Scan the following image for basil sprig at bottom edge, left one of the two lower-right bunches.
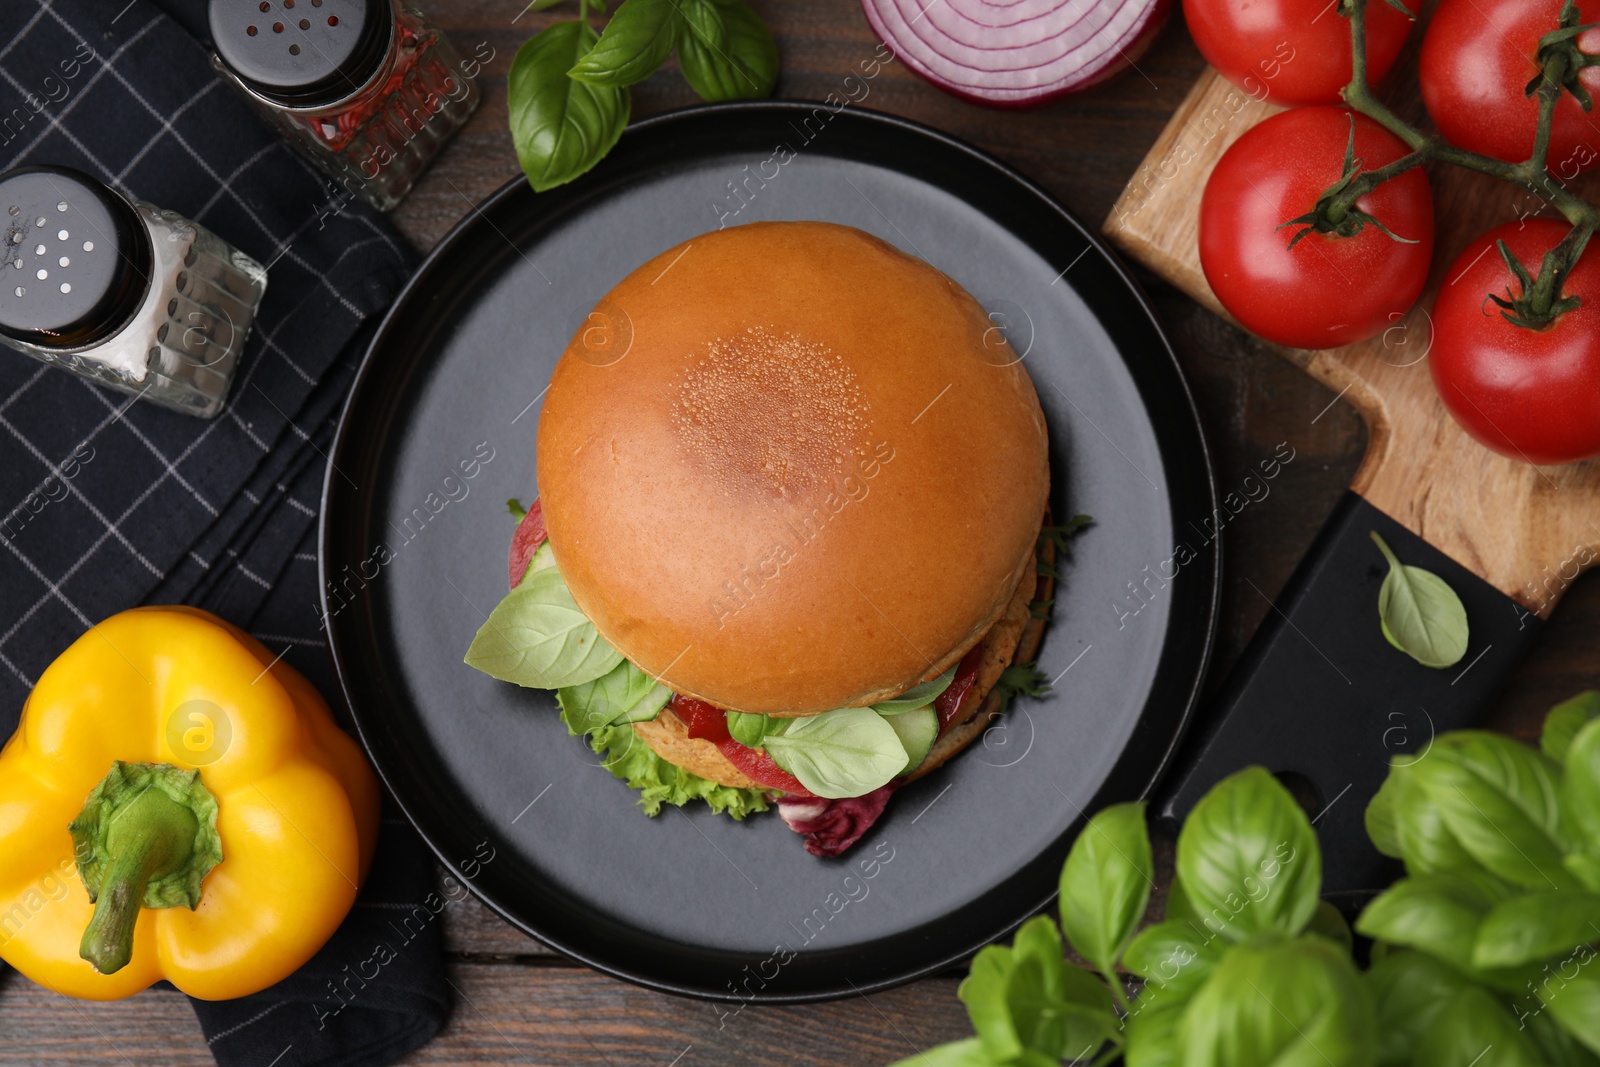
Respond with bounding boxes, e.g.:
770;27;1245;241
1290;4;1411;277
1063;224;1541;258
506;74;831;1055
896;768;1387;1067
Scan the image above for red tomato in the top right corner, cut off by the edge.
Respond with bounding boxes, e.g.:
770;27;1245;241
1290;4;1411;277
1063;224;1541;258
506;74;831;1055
1418;0;1600;178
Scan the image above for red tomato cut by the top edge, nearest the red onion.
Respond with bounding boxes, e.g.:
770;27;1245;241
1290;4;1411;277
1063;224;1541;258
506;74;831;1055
1184;0;1420;106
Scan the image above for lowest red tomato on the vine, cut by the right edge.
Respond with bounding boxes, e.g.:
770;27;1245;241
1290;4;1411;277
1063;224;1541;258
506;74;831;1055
1427;219;1600;464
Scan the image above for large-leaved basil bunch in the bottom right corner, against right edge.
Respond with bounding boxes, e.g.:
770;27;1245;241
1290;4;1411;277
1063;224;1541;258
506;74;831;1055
1355;693;1600;1064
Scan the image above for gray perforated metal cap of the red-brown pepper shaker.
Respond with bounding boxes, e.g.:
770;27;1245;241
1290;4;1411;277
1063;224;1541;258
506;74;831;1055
210;0;394;107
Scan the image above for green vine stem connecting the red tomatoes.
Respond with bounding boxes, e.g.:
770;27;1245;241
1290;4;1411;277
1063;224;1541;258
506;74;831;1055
1302;0;1600;330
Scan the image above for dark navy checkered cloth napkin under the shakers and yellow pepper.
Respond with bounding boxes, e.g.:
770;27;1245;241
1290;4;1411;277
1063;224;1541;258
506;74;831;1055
0;0;448;1067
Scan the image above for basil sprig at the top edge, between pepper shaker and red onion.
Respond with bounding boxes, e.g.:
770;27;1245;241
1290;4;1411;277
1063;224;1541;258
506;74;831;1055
507;0;778;192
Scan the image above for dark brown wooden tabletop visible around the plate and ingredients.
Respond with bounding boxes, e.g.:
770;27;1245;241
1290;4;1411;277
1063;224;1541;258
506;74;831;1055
0;0;1600;1067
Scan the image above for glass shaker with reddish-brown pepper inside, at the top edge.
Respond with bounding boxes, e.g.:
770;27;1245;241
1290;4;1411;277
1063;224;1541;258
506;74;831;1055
210;0;480;211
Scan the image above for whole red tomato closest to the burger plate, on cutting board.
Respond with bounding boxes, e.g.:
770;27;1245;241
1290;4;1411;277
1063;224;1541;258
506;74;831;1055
1200;107;1434;349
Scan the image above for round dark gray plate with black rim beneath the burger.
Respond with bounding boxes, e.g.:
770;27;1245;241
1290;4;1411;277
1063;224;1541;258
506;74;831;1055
322;102;1218;1001
